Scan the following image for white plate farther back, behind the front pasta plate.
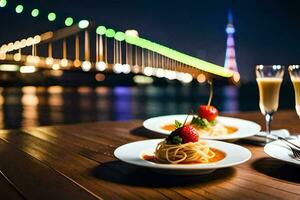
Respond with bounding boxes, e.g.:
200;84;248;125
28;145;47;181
143;115;261;140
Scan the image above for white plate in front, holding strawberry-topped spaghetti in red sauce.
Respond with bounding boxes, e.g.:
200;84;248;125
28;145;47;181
114;139;251;175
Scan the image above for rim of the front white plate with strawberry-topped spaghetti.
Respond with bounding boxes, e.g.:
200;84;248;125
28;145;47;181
114;139;252;171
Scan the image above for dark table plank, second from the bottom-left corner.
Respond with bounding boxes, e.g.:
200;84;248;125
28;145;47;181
0;140;96;199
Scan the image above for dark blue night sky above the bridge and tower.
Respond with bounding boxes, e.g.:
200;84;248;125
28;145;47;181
0;0;300;80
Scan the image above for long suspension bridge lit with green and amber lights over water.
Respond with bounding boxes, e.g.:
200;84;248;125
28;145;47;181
0;0;240;83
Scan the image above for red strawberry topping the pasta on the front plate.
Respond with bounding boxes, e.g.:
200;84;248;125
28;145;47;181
167;125;199;144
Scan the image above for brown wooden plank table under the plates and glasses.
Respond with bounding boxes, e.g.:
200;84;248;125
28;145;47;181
0;111;300;200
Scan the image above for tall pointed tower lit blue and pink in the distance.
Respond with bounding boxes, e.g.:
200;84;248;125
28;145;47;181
224;11;238;72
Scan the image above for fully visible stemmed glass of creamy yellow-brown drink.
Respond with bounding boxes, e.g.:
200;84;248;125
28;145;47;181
256;65;284;138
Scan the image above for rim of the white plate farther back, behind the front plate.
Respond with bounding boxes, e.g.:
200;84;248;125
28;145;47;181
143;114;261;140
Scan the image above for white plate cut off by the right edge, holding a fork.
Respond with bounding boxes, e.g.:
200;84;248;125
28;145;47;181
264;140;300;165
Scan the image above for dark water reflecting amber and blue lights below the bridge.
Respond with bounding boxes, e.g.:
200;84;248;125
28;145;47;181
0;84;294;129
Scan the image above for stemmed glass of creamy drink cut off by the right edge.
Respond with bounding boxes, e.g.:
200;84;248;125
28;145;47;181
289;65;300;117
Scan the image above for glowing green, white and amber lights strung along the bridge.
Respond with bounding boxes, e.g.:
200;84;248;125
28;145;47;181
0;0;233;82
